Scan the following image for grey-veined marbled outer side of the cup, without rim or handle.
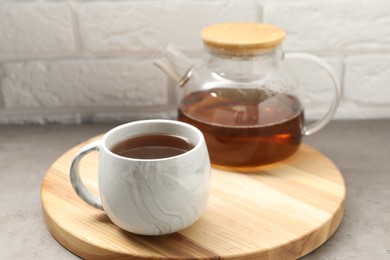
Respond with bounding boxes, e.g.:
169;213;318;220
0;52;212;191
99;144;211;235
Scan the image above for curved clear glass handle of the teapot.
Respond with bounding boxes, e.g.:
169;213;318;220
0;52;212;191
284;52;341;135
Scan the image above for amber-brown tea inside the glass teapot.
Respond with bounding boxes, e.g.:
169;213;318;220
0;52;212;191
178;88;303;167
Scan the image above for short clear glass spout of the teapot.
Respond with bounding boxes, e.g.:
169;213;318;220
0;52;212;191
153;44;193;86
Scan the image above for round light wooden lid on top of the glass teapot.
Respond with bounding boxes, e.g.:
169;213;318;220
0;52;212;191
201;22;285;54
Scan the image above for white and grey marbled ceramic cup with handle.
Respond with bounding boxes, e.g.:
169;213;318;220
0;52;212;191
70;120;211;235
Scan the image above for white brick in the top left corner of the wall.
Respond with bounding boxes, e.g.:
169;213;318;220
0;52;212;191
0;2;75;55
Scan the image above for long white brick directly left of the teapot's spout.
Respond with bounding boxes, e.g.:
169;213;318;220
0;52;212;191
0;59;168;109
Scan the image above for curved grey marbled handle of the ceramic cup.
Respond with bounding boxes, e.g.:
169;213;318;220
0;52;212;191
70;140;103;210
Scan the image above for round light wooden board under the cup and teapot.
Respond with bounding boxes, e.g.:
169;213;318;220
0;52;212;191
41;137;345;259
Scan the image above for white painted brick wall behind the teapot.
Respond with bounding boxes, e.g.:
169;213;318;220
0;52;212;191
0;0;390;124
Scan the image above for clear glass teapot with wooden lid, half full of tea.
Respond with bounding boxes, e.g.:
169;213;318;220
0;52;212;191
155;23;340;171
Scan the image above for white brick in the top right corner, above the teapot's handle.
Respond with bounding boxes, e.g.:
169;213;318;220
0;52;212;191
264;0;390;51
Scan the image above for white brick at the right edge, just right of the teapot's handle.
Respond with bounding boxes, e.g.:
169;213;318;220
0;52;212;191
345;55;390;106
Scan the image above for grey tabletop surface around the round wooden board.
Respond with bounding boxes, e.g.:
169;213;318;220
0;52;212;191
0;120;390;259
